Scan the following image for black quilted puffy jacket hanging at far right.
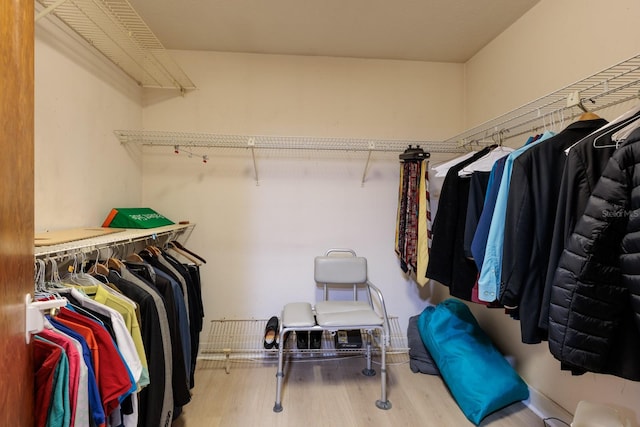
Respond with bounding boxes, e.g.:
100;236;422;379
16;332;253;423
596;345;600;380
549;131;640;381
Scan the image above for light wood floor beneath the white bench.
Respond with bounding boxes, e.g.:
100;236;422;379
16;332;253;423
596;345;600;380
172;355;544;427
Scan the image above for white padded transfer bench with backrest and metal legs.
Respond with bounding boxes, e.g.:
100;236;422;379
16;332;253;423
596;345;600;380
273;249;391;412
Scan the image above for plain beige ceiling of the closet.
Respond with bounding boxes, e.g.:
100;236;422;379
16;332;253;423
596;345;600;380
129;0;539;62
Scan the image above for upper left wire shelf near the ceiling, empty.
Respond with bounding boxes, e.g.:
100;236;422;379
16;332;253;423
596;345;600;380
35;0;195;94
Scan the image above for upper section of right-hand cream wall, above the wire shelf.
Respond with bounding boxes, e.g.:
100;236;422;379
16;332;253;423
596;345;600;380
465;0;640;127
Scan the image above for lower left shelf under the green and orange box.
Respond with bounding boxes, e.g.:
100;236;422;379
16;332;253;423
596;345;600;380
34;224;195;258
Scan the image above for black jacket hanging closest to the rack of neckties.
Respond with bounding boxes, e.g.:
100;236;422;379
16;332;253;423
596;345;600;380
426;147;495;301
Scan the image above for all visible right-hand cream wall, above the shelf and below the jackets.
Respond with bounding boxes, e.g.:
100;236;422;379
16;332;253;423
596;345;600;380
466;0;640;422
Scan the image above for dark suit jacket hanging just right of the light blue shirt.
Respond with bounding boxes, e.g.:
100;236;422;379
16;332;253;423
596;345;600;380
499;119;607;344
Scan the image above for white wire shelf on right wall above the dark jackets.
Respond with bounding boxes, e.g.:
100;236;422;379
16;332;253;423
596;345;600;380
444;55;640;147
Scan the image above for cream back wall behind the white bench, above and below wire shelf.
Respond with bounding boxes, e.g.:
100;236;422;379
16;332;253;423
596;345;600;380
143;52;463;340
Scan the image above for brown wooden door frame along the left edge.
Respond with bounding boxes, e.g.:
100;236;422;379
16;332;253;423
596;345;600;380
0;0;34;426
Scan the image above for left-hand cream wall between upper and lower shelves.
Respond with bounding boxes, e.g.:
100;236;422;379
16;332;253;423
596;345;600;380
35;19;142;232
